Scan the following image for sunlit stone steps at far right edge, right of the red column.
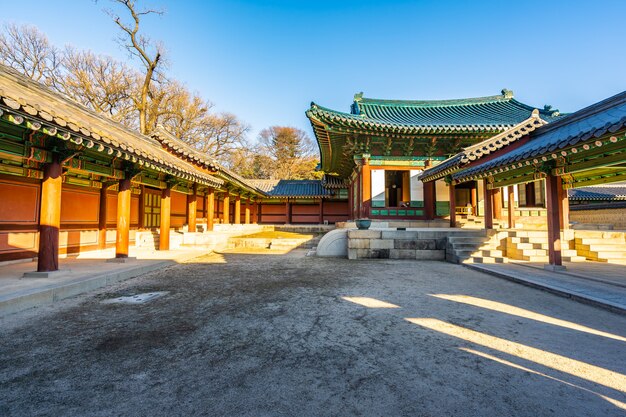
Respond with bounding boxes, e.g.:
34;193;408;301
574;231;626;265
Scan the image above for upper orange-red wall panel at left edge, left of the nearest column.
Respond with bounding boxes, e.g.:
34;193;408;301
0;179;40;226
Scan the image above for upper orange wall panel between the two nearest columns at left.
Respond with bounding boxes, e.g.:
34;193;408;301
61;187;100;224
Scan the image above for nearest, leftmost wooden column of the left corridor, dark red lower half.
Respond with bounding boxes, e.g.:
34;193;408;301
37;156;63;272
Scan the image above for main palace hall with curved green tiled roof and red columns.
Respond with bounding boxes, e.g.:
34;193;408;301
307;90;561;220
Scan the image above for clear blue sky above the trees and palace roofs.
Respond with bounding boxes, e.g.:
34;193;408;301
0;0;626;143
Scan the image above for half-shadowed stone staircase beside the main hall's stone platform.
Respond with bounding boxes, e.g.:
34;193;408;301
446;231;506;263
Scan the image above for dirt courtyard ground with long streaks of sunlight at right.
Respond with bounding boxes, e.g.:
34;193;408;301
0;251;626;417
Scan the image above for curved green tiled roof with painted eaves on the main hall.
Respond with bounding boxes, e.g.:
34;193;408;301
306;90;561;178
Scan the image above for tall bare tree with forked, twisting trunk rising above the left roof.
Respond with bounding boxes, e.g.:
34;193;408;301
108;0;163;134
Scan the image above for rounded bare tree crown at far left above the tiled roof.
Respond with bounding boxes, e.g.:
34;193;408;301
0;23;62;87
